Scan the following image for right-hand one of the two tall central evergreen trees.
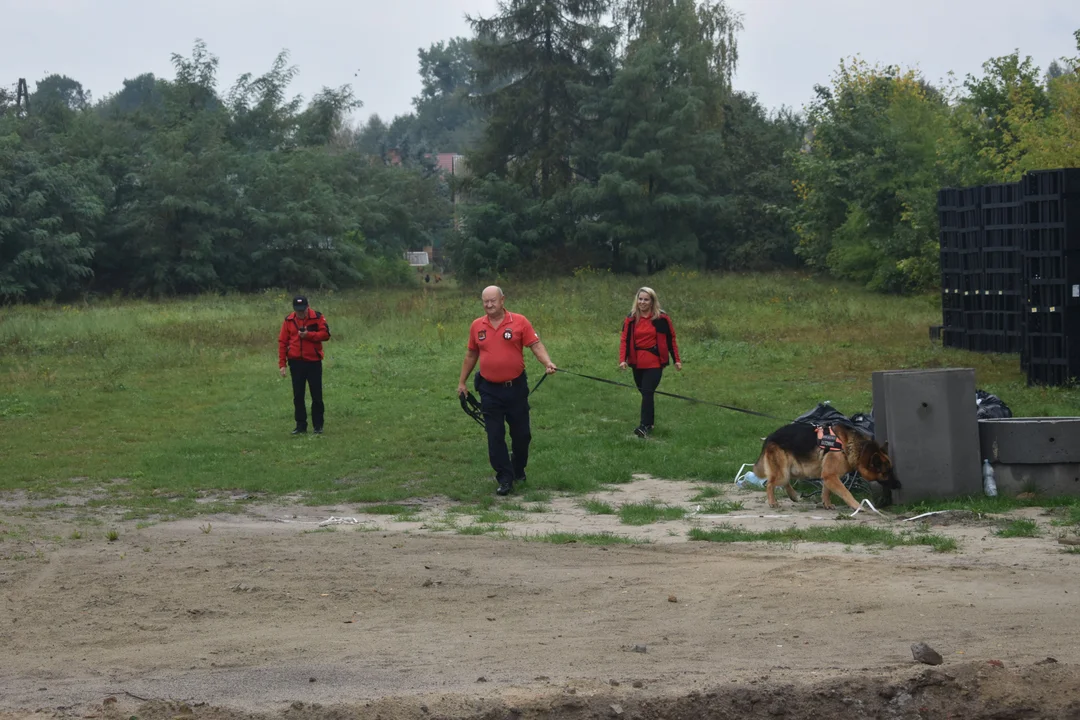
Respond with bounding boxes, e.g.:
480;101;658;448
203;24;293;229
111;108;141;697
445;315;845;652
573;0;734;272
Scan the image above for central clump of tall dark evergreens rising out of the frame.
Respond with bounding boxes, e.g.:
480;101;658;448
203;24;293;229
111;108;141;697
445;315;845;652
442;0;806;275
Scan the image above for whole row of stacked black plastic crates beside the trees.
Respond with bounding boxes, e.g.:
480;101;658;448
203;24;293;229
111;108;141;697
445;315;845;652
937;169;1080;385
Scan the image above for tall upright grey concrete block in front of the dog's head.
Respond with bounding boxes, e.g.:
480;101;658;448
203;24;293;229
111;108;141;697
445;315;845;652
873;368;983;503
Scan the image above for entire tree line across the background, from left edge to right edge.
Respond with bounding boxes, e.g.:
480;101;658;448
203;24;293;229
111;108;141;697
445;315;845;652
0;0;1080;301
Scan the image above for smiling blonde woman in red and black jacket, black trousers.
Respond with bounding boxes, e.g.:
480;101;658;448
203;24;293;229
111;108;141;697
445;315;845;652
619;287;683;437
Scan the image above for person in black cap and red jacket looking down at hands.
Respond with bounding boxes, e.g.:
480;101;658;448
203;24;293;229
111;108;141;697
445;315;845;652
278;295;330;435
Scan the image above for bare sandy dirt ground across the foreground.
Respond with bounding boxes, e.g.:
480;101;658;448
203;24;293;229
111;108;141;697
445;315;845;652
0;477;1080;720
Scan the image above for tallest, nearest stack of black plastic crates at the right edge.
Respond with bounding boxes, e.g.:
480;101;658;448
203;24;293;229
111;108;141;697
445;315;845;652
1021;168;1080;385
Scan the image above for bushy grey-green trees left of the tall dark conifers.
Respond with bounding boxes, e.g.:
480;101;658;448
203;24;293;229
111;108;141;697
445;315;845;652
0;43;450;301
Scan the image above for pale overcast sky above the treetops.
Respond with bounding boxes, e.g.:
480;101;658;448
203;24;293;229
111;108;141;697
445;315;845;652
0;0;1080;120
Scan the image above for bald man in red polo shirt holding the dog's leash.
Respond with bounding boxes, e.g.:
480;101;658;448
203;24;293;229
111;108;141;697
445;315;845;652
458;285;558;495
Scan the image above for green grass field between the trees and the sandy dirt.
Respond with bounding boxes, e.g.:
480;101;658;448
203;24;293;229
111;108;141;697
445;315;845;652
0;271;1080;517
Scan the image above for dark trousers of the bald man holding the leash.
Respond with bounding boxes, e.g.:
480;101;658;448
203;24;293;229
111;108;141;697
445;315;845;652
474;372;532;483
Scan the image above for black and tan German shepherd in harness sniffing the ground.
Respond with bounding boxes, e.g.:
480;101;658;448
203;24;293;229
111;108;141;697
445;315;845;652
754;422;900;510
